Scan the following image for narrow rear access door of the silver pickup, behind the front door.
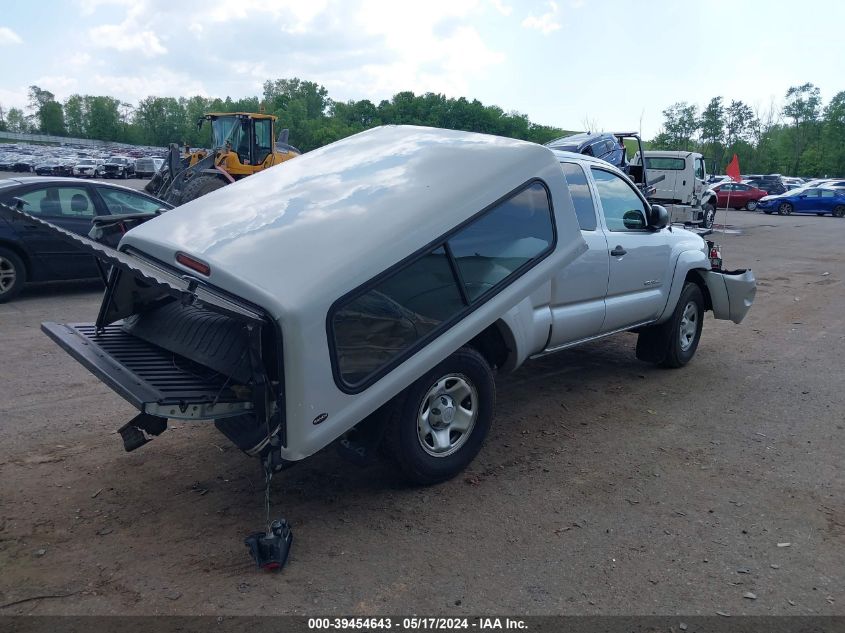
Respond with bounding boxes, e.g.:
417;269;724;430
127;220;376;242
549;158;610;348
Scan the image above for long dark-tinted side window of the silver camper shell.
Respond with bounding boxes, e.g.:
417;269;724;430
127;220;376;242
328;181;555;393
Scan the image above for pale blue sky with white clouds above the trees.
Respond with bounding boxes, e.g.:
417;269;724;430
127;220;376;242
0;0;845;138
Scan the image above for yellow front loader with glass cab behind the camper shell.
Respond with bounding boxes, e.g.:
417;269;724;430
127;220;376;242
145;112;300;205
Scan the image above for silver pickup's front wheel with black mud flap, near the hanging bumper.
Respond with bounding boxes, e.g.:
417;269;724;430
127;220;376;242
637;282;704;368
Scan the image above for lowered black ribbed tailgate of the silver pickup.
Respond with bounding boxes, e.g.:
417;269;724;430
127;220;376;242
41;323;252;419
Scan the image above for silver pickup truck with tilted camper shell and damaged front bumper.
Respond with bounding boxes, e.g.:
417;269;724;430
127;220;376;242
24;126;755;483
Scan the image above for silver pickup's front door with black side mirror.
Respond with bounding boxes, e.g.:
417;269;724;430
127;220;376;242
591;166;671;332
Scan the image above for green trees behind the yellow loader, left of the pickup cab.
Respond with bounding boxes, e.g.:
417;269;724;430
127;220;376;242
0;78;567;151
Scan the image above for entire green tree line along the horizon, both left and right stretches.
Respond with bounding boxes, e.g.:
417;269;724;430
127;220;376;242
0;78;845;176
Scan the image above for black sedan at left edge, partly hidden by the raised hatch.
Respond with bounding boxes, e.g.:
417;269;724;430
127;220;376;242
0;177;173;303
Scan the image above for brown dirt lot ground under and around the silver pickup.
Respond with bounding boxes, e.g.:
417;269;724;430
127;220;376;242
0;211;845;615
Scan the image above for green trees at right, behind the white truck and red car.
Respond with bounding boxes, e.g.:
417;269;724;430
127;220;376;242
649;83;845;176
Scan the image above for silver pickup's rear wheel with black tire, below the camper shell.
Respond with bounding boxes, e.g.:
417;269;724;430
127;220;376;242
385;347;496;486
